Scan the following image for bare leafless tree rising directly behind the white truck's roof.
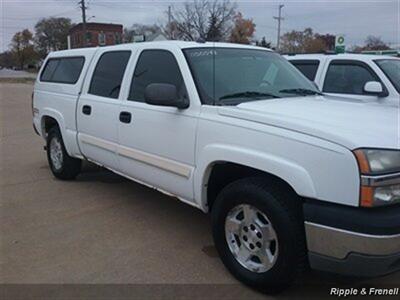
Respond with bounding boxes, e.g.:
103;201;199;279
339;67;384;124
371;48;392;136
166;0;236;41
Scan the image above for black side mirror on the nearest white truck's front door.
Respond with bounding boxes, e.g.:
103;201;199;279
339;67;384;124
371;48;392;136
144;83;189;109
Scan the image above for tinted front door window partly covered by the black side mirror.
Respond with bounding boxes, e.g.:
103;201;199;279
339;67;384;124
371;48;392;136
128;50;185;102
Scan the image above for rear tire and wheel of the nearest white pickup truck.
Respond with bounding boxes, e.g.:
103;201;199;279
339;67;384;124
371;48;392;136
47;126;82;180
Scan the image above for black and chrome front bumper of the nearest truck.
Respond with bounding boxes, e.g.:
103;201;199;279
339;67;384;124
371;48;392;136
304;202;400;276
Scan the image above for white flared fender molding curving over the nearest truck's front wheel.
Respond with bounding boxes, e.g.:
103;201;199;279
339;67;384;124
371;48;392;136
194;144;316;212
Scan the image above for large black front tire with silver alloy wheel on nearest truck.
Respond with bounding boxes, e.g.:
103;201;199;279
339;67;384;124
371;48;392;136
211;178;306;293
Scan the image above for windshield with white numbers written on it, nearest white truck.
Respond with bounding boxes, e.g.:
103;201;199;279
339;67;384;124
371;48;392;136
184;47;321;105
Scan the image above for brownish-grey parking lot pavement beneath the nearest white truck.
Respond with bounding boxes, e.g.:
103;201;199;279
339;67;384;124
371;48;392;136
0;83;400;299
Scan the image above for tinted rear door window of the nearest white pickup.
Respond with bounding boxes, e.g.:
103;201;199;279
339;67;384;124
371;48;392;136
89;51;131;99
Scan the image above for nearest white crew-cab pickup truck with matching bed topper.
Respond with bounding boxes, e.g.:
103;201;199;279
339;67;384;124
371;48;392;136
32;41;400;292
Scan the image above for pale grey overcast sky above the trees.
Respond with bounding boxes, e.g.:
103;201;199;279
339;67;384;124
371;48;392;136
0;0;400;51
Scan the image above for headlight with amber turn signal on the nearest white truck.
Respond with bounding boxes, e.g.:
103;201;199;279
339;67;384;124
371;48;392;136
354;149;400;207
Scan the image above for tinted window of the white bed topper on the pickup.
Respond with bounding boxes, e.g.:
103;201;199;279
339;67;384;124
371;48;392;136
40;57;85;84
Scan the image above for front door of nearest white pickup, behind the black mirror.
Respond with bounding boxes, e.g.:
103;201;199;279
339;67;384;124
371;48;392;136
118;49;200;202
